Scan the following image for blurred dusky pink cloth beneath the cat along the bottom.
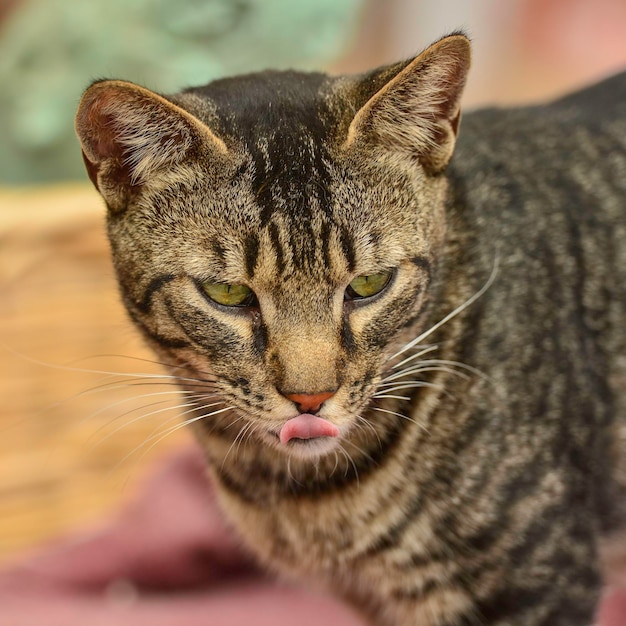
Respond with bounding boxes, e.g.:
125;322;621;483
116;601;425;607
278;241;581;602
0;449;626;626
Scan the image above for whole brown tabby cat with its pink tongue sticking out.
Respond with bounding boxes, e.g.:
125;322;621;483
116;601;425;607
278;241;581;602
76;33;626;626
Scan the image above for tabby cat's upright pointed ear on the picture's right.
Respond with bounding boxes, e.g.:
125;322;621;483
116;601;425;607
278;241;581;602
344;34;471;173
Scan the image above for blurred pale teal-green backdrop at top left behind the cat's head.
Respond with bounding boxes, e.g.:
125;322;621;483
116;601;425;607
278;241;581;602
0;0;362;184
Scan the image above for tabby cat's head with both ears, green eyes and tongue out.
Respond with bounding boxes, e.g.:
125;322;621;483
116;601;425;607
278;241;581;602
76;35;469;458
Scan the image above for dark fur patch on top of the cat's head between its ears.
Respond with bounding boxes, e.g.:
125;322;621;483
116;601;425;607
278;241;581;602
189;72;338;226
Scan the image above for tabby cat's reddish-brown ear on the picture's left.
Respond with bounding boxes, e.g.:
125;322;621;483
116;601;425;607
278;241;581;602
75;80;227;210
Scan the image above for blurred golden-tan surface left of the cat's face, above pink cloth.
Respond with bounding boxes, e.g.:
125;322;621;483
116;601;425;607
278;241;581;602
0;186;187;561
